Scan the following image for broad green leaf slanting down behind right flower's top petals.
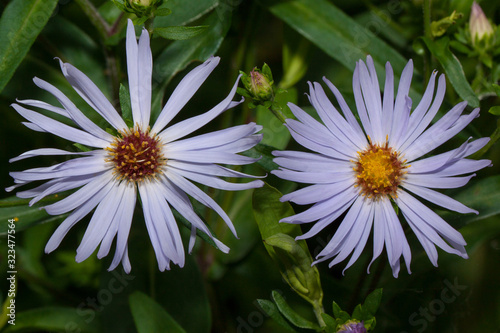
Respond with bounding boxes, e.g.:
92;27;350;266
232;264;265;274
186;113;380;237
258;0;407;87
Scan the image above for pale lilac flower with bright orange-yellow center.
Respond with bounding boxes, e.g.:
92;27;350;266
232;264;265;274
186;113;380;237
273;56;491;277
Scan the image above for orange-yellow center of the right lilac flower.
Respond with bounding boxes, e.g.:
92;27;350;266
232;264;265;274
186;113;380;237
353;143;409;199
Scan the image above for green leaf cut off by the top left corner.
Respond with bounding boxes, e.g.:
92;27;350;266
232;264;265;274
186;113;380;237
0;0;58;92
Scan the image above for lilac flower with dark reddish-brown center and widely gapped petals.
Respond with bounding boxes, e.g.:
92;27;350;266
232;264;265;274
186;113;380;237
7;20;263;272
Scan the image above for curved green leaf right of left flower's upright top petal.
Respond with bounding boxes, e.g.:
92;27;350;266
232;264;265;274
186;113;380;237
151;7;231;119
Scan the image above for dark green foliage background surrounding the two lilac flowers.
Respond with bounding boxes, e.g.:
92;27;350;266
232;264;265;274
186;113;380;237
0;0;500;333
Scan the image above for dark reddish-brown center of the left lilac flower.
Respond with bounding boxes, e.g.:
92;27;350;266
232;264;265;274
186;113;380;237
106;127;166;182
